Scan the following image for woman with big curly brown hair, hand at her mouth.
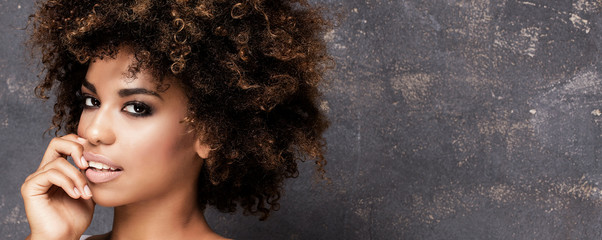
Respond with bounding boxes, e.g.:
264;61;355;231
21;0;329;239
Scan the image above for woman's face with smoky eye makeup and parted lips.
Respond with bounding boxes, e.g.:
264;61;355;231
77;51;204;206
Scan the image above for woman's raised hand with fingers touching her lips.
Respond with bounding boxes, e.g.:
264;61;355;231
21;134;95;240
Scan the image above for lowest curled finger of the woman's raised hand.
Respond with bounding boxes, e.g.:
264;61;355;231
21;169;82;199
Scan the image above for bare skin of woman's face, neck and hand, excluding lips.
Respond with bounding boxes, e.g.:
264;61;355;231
21;48;224;240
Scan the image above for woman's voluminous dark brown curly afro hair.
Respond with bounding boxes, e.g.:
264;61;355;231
30;0;331;220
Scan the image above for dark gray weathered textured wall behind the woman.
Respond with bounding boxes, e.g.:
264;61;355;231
0;0;602;239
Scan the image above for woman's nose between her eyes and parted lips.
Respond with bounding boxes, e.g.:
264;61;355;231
79;107;115;145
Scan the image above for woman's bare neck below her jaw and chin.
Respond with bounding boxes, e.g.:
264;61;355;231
111;182;214;240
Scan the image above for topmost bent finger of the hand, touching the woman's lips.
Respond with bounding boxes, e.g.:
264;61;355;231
38;134;88;169
